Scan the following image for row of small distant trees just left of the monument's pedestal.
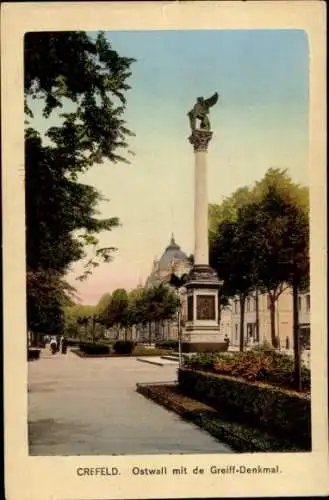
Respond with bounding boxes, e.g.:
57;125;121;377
65;283;179;341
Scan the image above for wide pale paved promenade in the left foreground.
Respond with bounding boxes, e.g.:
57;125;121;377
28;351;231;455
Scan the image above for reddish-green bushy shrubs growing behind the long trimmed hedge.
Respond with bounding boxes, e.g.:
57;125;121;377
185;349;311;391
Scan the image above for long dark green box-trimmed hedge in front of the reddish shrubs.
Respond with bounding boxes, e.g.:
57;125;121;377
178;368;311;450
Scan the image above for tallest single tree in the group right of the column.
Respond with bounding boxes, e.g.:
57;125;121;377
243;169;308;346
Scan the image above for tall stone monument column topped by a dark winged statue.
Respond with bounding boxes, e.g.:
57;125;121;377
182;94;224;352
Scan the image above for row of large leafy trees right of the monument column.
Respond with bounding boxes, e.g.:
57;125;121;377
209;169;309;386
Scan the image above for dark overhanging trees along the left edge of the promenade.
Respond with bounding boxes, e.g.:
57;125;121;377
24;32;133;344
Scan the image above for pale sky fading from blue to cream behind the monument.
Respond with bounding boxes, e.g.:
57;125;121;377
30;30;309;303
